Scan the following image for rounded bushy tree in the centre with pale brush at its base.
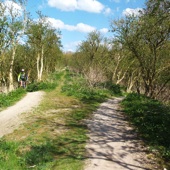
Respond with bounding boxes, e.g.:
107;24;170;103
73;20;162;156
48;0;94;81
74;31;108;86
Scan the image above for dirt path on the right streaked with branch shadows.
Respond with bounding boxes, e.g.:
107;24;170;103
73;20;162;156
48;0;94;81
85;98;156;170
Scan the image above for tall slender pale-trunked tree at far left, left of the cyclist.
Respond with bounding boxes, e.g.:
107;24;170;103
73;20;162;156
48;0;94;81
0;0;27;91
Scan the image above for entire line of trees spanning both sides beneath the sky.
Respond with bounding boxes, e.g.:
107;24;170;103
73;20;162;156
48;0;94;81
0;0;170;101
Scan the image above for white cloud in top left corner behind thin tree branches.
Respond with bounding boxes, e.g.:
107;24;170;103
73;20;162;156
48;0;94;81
2;0;23;17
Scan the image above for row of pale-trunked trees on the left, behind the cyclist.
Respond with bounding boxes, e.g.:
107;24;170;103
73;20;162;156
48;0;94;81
0;0;62;92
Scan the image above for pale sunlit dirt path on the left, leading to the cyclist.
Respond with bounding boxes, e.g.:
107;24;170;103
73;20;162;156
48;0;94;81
0;91;44;137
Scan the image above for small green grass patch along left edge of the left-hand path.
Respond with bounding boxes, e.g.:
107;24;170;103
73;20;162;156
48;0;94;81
0;88;26;108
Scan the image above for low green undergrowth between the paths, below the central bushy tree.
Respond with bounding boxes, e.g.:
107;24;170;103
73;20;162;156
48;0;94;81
62;72;121;103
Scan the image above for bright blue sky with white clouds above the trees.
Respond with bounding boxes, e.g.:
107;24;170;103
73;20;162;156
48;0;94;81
5;0;145;52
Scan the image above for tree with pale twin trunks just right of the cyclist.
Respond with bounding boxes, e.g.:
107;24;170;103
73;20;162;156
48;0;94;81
27;12;61;81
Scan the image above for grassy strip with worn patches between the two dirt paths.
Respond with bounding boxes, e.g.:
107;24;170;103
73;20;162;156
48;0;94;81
0;69;120;170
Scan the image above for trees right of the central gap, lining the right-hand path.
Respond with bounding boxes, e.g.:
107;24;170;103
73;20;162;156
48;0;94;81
64;0;170;101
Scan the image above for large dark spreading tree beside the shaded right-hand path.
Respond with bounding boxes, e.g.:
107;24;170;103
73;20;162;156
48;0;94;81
111;1;170;97
